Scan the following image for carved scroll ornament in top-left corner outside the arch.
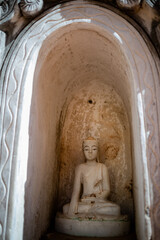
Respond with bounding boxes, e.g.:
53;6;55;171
0;0;44;35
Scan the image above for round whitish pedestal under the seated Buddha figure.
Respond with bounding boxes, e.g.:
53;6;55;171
55;214;130;237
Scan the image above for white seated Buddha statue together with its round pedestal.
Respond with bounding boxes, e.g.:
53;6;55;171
55;137;130;237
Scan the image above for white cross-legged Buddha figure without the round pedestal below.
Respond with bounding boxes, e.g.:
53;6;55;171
63;137;120;219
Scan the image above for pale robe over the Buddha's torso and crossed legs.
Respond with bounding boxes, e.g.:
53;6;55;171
63;163;120;219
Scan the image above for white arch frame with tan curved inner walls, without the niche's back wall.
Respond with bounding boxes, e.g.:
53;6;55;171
0;1;160;240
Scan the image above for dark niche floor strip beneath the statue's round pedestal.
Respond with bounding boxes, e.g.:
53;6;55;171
42;232;137;240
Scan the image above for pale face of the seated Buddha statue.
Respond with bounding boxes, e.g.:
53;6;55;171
83;140;98;161
